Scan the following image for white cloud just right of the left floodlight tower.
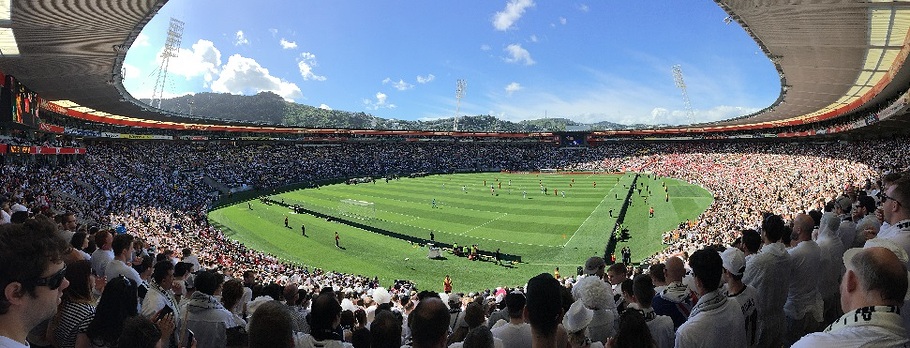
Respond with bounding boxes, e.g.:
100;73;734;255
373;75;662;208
164;39;221;87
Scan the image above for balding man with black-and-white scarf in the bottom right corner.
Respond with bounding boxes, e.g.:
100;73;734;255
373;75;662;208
793;239;910;348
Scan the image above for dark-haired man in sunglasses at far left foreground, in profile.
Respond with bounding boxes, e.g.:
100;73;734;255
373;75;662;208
0;220;70;347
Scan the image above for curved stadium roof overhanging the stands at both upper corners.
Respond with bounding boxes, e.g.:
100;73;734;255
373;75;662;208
0;0;910;133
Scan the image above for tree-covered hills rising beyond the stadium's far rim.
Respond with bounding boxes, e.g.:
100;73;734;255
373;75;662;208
141;92;651;132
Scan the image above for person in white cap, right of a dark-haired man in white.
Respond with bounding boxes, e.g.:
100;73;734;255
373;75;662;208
720;248;758;347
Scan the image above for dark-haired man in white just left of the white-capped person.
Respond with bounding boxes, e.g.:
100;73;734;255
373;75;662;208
675;248;748;348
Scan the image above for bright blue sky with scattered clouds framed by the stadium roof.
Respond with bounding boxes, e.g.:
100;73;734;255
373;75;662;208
124;0;780;124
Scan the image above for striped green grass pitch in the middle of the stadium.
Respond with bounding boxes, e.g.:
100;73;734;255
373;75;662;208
209;173;713;292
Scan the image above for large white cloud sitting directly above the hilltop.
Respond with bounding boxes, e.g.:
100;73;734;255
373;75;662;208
212;54;303;101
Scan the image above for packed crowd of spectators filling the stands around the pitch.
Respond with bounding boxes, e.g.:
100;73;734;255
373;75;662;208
0;139;910;347
